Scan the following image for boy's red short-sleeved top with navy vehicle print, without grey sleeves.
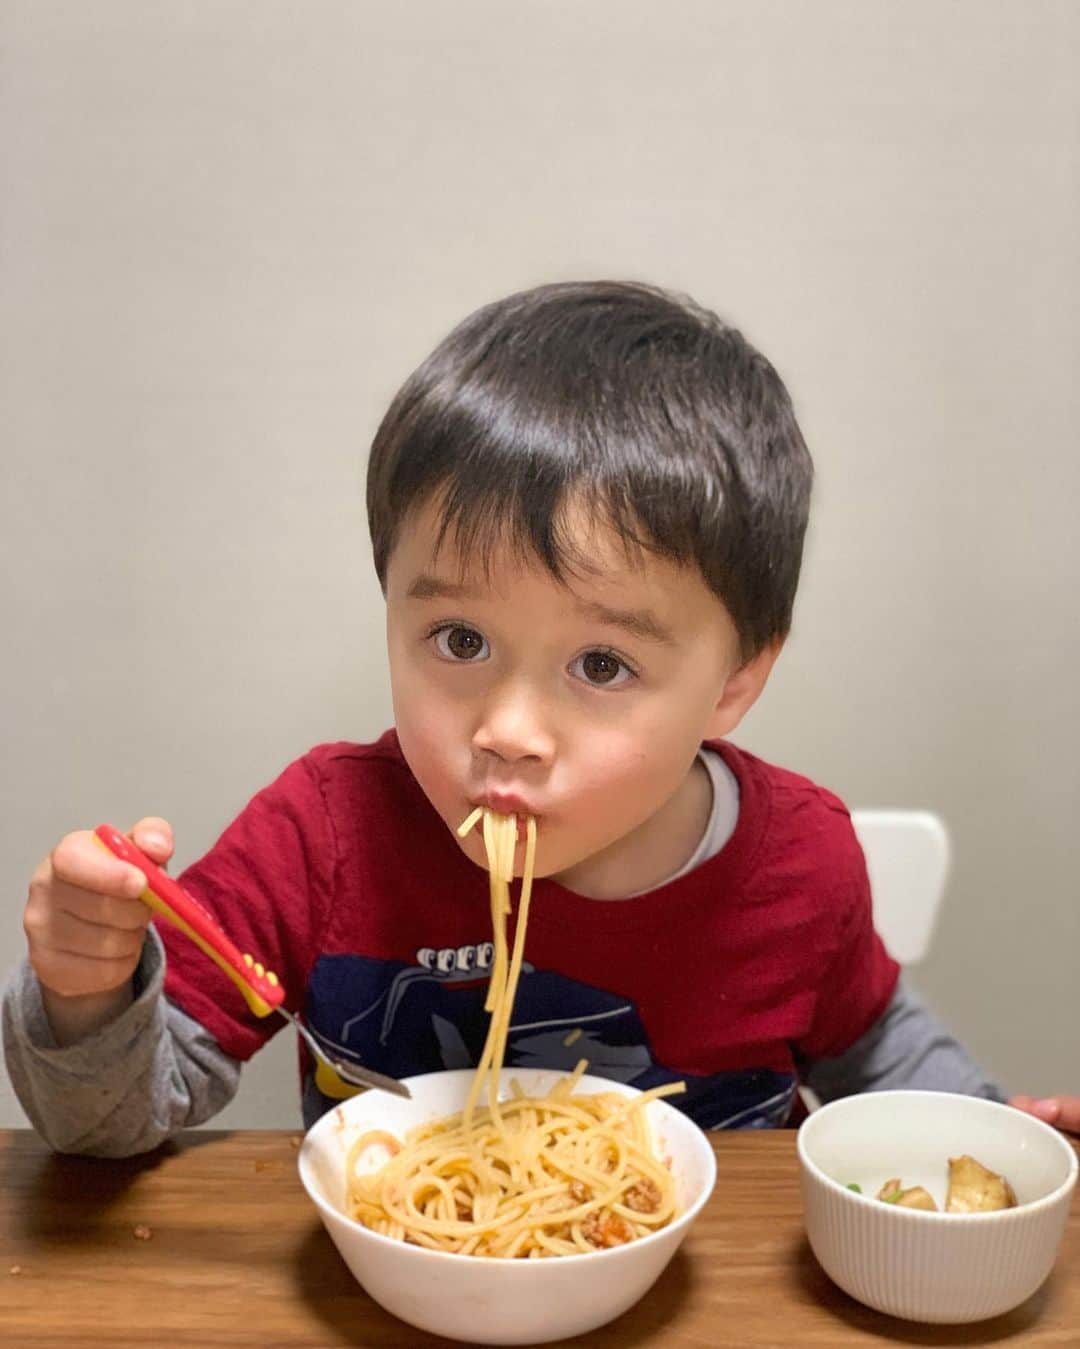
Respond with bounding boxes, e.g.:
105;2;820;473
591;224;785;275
159;731;898;1128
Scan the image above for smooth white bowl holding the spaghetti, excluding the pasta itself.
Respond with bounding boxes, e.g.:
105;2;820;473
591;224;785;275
299;1068;716;1345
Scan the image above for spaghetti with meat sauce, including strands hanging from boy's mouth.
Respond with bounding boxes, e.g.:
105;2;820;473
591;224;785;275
347;809;684;1259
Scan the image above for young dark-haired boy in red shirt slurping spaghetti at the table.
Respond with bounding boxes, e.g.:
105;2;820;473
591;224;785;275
4;283;1071;1155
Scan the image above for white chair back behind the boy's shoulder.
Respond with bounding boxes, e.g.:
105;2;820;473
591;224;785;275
851;811;949;965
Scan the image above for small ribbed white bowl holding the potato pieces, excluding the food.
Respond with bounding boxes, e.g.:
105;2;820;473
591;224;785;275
798;1091;1077;1323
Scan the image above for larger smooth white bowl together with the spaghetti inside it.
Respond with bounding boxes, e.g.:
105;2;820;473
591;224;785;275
299;1068;716;1345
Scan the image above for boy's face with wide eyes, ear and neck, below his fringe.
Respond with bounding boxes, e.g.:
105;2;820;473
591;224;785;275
387;505;774;898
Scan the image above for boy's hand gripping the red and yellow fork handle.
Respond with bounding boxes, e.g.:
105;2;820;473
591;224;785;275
23;816;173;1044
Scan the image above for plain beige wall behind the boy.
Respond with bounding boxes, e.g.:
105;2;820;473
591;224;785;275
0;0;1080;1125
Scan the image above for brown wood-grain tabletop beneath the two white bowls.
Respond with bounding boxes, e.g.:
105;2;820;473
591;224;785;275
0;1130;1080;1349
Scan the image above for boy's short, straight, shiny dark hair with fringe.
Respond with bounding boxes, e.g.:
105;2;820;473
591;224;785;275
368;282;812;658
